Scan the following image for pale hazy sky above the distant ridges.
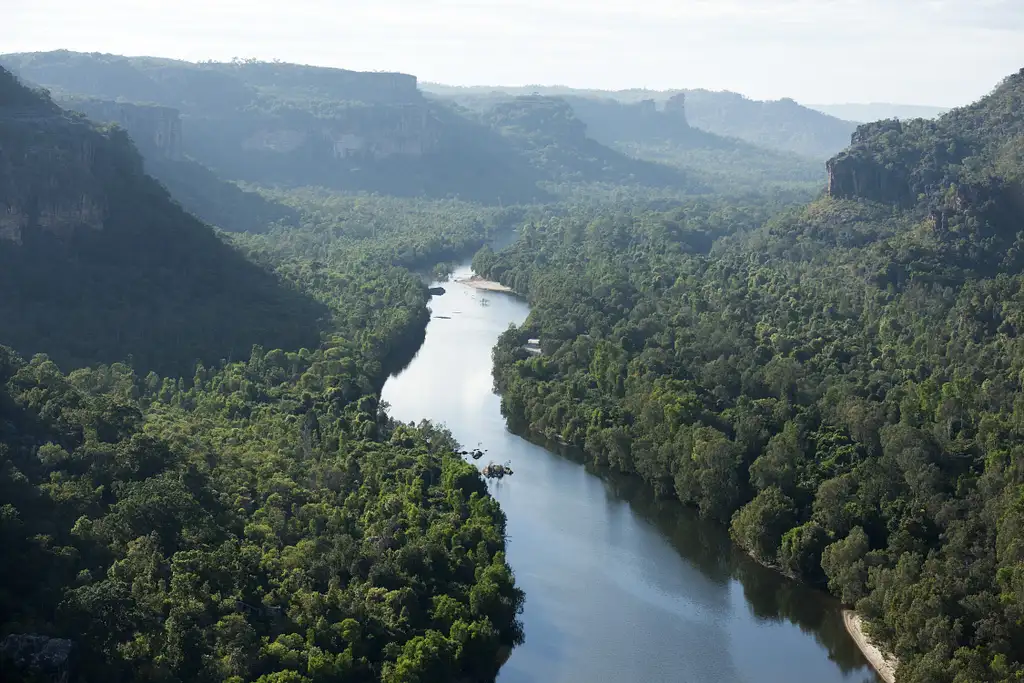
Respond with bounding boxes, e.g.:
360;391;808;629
8;0;1024;105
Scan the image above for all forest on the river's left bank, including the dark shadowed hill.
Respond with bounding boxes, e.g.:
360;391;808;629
0;65;523;683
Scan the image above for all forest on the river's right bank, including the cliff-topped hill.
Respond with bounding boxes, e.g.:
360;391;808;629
474;69;1024;683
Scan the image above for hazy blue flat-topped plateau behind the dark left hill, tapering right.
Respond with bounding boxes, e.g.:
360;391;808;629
0;51;708;201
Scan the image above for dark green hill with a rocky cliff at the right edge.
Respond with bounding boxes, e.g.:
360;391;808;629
827;70;1024;274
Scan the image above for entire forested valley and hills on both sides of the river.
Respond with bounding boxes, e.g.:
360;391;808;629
0;41;1024;683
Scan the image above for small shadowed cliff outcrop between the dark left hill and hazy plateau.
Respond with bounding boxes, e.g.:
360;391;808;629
59;98;182;161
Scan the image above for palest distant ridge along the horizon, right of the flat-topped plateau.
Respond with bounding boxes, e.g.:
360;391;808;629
422;83;855;160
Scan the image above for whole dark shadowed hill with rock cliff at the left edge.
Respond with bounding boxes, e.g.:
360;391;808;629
0;70;324;371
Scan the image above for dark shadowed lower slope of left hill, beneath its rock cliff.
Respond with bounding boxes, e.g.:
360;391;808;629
0;171;328;375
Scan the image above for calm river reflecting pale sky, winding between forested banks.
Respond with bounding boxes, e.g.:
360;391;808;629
383;267;879;683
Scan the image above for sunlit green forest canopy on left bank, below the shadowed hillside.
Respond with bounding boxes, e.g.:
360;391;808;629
0;347;522;681
